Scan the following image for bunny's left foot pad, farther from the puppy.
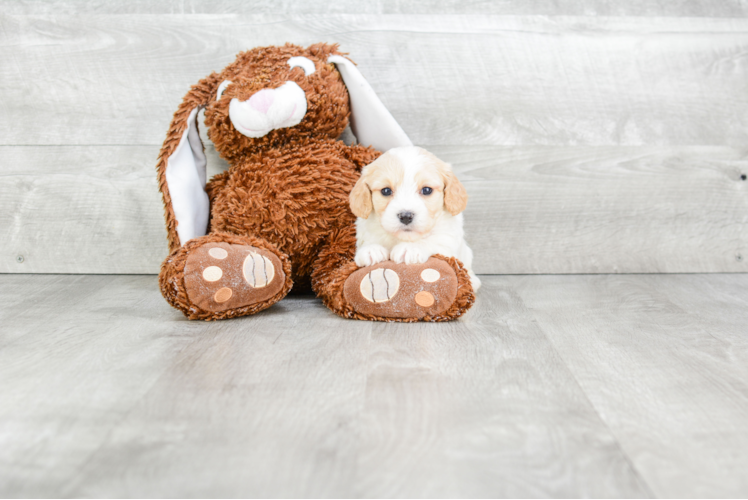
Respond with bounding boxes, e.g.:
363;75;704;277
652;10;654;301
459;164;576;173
184;242;286;312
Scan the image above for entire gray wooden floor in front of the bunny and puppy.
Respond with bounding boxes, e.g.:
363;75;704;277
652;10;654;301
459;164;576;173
0;274;748;498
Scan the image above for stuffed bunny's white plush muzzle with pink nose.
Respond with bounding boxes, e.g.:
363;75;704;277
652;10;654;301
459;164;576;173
229;82;307;138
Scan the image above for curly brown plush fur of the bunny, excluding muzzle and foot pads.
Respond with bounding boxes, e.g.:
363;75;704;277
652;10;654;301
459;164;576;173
157;44;474;321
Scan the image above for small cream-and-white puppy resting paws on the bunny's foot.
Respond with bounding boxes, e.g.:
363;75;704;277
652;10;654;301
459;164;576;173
350;146;480;290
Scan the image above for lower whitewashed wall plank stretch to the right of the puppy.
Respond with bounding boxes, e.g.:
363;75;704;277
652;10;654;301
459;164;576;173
444;147;748;274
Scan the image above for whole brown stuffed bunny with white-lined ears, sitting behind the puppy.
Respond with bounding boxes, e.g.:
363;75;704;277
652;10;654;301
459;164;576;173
157;44;474;321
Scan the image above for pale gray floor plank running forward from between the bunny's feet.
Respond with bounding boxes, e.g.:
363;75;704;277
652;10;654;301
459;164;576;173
63;292;372;498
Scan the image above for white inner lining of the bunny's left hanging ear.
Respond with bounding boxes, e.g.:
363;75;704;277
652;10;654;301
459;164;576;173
166;108;210;245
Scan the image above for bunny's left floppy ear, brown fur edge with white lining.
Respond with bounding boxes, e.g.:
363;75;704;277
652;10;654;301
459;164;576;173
156;73;218;252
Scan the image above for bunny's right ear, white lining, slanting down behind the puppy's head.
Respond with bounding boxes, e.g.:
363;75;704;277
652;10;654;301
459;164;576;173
327;55;413;151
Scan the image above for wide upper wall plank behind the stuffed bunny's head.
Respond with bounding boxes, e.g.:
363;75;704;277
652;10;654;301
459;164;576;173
0;13;748;146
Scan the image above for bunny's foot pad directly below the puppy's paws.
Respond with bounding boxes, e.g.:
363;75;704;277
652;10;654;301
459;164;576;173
343;257;458;320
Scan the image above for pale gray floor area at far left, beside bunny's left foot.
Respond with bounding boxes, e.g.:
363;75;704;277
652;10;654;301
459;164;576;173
0;275;199;498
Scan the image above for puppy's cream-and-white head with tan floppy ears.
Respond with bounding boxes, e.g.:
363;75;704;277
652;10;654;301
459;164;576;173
350;146;467;241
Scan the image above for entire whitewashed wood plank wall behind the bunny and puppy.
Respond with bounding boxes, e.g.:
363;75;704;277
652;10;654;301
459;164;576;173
0;0;748;274
